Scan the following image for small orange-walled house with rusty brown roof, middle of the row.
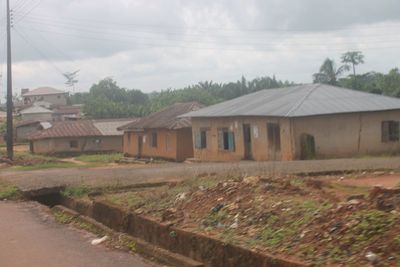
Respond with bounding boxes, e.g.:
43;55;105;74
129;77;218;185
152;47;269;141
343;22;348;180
121;102;202;161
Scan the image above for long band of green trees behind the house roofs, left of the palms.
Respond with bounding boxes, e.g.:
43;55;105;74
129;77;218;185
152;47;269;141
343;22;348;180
69;77;292;119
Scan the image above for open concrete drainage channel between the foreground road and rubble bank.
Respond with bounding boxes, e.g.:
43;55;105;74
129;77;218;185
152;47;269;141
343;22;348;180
24;187;307;267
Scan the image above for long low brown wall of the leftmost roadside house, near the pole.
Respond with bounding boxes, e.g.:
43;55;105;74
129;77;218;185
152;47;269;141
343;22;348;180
31;136;122;154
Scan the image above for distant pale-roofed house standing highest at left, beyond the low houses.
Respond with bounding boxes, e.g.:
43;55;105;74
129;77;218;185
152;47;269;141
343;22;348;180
21;87;68;106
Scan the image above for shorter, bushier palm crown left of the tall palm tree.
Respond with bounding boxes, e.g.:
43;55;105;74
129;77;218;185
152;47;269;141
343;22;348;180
313;58;349;85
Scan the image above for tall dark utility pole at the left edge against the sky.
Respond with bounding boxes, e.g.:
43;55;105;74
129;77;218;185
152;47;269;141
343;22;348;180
7;0;14;160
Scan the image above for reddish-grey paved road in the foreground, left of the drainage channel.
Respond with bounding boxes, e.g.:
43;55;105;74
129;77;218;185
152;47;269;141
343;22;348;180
0;201;159;267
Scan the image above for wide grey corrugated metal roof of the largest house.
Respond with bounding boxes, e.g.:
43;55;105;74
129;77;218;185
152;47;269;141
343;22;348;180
181;84;400;117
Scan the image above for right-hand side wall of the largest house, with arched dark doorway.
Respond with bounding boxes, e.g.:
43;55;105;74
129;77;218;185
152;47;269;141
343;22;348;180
293;111;400;158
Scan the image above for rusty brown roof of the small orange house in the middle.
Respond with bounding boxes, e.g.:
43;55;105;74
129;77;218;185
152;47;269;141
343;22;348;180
120;102;203;130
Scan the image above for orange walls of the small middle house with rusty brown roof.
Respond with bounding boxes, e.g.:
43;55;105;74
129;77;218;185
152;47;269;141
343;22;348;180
124;129;193;161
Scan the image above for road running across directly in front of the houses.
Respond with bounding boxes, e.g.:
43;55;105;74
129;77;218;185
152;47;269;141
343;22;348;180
0;157;400;193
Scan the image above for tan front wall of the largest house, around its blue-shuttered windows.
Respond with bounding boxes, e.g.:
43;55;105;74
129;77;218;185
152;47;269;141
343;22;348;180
192;117;293;161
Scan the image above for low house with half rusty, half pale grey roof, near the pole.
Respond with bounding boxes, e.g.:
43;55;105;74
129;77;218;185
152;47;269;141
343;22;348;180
29;119;136;154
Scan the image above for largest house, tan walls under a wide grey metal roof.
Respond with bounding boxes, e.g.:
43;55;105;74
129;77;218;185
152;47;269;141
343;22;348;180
183;84;400;161
